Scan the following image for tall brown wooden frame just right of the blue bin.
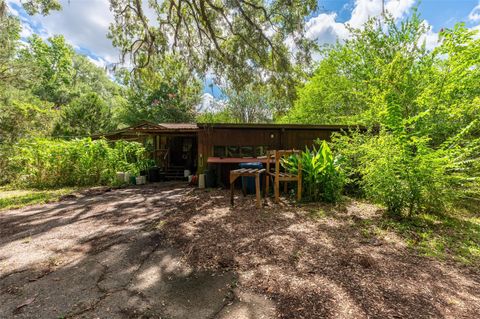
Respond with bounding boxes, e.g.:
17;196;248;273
265;150;302;203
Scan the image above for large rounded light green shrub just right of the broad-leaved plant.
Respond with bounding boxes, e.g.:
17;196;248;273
335;131;456;215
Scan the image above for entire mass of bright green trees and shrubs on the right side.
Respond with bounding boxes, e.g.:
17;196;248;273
283;11;480;216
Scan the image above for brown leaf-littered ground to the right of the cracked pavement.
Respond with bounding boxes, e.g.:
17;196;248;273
158;191;480;318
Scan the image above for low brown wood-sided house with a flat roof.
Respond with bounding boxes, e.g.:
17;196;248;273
97;122;352;177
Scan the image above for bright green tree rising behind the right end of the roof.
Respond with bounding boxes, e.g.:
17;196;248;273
283;12;435;125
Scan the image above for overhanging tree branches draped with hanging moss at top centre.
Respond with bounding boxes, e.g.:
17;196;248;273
15;0;318;107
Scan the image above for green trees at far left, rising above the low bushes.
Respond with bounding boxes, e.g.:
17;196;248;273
0;12;124;139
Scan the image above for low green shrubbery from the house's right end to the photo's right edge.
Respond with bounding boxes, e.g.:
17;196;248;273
333;127;480;217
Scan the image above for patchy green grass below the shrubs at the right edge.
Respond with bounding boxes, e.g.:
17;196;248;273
362;211;480;265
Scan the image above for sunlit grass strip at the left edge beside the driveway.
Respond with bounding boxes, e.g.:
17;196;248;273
0;187;79;210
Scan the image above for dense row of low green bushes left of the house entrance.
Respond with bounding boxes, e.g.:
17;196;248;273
7;138;147;188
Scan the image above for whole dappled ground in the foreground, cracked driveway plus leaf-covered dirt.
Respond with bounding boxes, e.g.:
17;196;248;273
0;184;480;319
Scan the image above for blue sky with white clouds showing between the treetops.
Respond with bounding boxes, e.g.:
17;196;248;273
7;0;480;105
